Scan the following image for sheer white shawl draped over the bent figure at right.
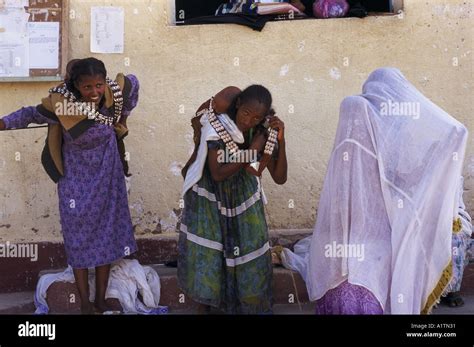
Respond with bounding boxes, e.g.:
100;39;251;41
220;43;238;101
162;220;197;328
306;68;468;314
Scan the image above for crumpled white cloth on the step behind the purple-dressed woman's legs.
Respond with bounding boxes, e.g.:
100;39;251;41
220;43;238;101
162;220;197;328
35;259;168;314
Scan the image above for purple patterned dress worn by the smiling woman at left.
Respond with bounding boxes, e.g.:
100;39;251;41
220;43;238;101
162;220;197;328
3;75;139;269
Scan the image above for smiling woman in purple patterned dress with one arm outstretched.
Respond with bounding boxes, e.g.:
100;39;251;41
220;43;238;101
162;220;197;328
0;58;139;313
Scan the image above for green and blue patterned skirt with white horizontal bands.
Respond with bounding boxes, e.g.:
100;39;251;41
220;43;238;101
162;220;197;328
178;165;272;314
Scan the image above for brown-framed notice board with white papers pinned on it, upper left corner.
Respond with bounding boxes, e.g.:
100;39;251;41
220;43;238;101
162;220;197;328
0;0;68;82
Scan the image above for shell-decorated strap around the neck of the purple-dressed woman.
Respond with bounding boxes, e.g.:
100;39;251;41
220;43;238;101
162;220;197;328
49;78;123;126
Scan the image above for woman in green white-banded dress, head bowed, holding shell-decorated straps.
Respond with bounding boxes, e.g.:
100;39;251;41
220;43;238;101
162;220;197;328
178;85;287;314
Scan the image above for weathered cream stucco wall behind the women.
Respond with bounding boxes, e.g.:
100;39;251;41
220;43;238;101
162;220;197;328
0;0;474;241
